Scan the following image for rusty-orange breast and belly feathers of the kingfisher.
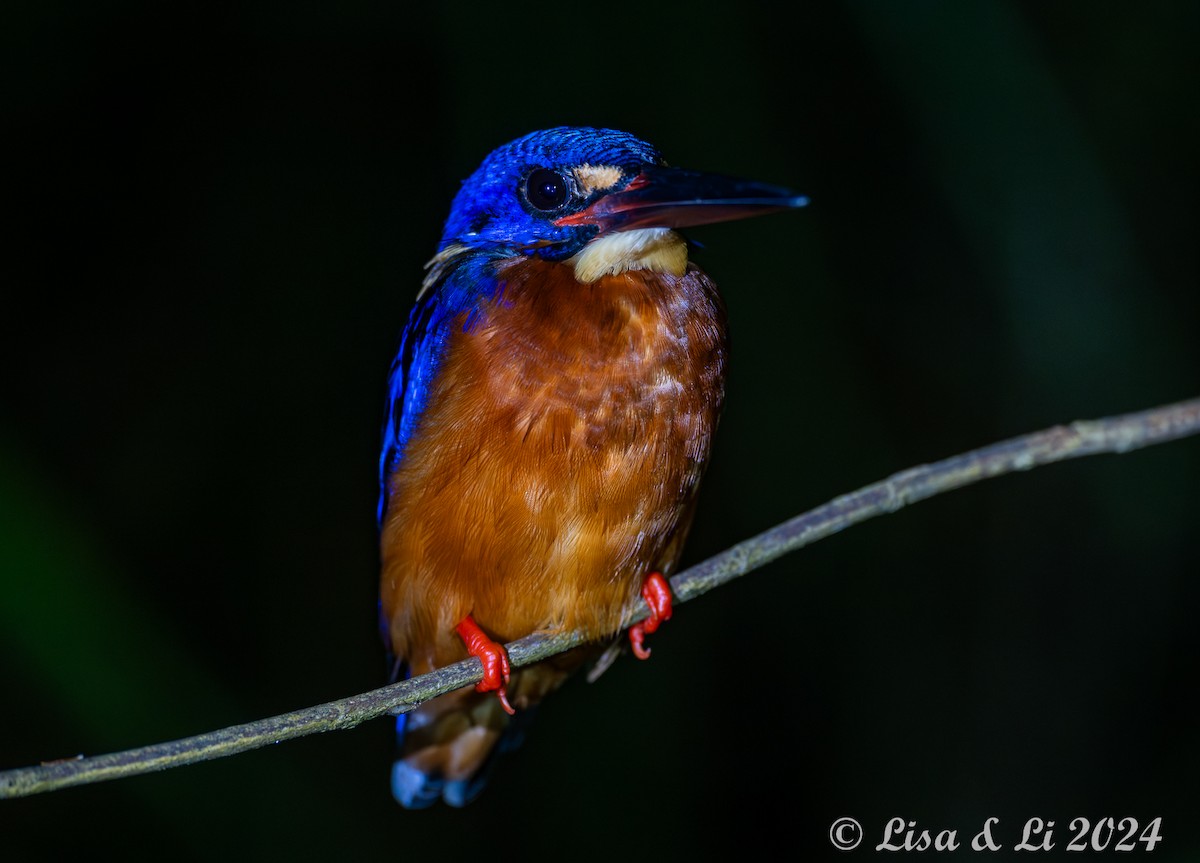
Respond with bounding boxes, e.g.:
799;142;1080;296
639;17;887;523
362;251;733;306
382;257;727;673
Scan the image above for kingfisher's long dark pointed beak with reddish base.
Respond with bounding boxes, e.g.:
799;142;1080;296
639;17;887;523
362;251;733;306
554;167;809;232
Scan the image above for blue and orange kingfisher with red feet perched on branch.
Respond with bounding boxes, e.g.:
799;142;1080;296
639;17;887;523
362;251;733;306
378;127;806;809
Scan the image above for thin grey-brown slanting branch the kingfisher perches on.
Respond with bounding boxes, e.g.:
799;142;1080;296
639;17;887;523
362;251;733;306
0;398;1200;798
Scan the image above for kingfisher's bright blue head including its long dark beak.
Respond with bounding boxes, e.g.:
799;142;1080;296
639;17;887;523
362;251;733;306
439;127;806;281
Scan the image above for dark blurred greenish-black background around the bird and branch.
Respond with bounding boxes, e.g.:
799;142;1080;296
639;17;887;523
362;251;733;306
0;0;1200;861
